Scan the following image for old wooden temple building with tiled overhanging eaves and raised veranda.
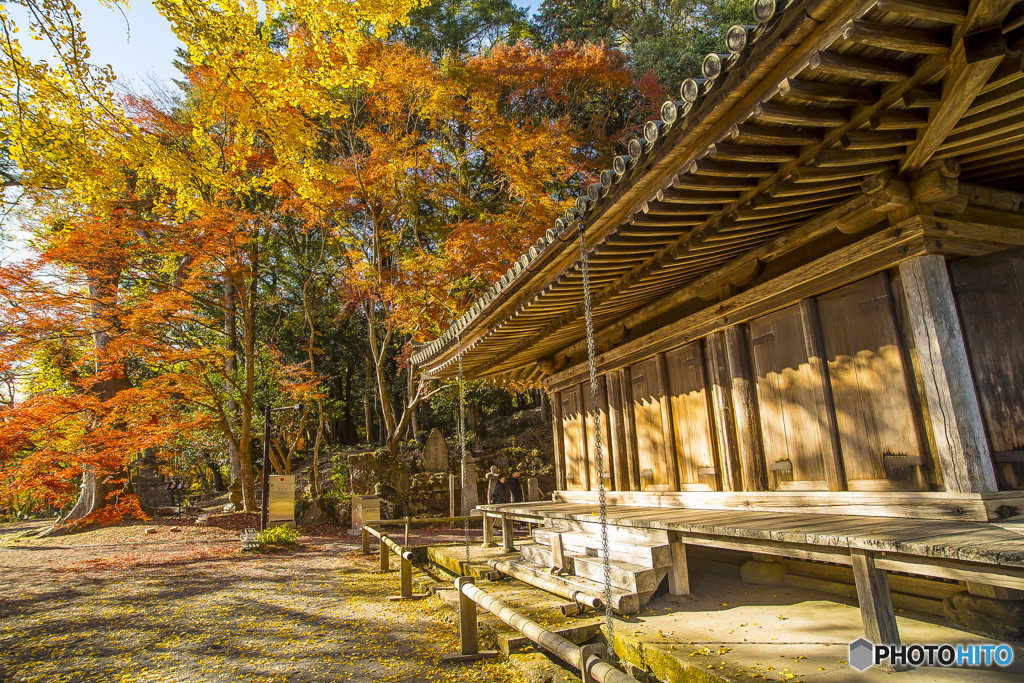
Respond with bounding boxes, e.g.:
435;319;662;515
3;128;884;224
414;0;1024;642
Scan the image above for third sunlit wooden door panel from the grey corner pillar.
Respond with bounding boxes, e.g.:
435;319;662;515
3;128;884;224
665;341;719;490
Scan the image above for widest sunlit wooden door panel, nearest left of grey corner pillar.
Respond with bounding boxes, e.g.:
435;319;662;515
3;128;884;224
818;272;927;490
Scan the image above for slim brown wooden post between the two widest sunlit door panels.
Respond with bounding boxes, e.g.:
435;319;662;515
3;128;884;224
800;299;846;490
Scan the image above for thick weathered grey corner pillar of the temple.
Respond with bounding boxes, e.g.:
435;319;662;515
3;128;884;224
899;254;996;494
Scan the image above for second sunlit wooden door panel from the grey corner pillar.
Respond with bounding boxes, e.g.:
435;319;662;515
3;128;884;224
751;304;827;490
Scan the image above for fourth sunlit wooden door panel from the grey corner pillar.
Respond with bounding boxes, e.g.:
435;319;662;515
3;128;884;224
631;358;676;490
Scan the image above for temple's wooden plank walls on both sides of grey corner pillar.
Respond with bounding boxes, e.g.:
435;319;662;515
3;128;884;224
553;258;1024;492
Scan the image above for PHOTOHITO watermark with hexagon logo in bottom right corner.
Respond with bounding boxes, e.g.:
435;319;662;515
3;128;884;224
850;638;1014;671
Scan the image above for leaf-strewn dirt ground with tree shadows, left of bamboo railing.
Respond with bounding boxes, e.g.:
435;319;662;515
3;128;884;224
0;533;518;683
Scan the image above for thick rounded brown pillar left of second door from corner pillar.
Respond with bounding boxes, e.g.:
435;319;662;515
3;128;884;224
722;325;768;490
